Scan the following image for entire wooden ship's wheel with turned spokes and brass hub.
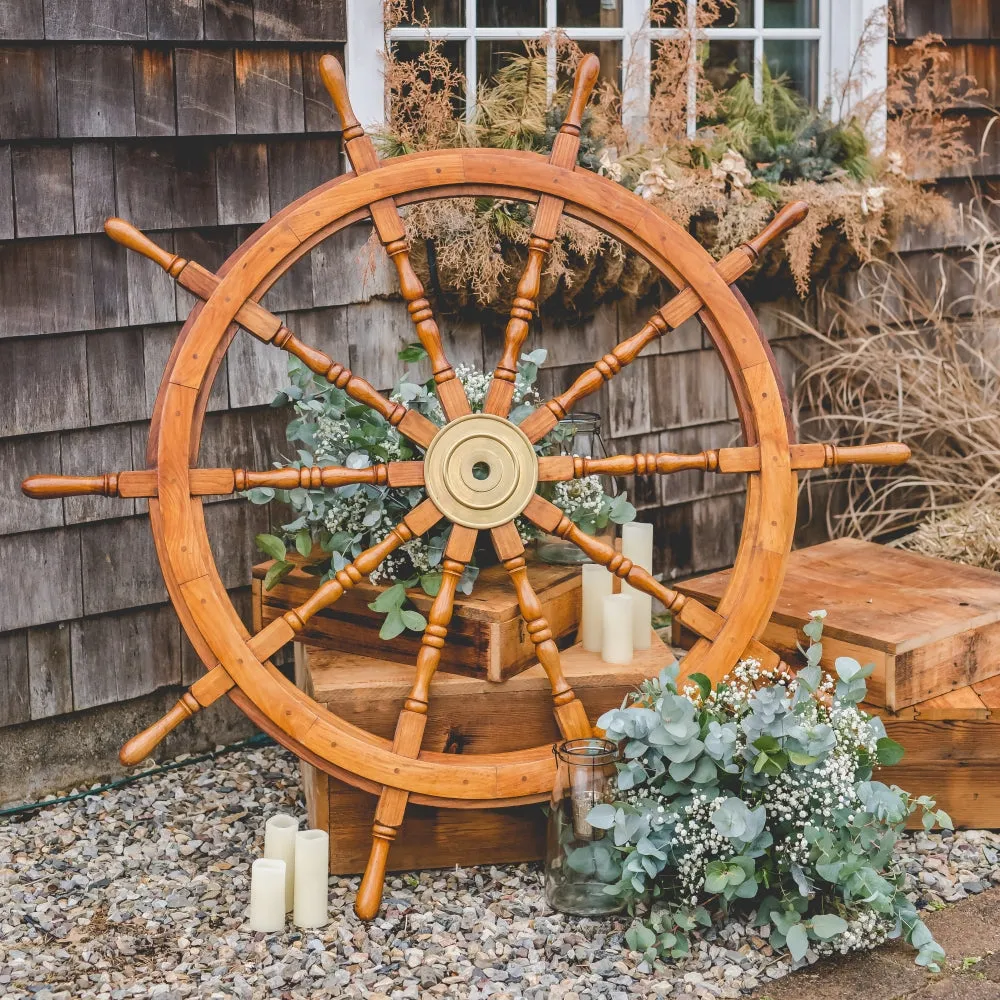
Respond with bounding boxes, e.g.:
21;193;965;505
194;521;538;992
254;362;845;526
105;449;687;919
23;55;909;918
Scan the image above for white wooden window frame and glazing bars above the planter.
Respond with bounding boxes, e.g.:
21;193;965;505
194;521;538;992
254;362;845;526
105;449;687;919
347;0;888;134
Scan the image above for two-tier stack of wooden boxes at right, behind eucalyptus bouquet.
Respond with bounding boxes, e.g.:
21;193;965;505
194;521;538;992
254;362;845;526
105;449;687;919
674;539;1000;829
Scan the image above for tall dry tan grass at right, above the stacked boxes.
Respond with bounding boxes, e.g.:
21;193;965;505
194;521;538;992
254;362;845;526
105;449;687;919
789;206;1000;542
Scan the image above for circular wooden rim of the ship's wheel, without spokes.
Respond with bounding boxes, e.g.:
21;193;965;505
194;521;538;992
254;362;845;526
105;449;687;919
150;150;796;804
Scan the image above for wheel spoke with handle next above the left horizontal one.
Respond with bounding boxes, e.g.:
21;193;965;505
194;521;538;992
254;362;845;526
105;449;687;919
104;219;438;448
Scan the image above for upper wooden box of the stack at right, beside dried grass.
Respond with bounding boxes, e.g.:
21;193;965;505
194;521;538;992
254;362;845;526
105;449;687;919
674;538;1000;712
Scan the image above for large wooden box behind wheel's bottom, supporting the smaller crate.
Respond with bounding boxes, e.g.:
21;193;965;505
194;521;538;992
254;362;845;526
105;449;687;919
295;640;674;874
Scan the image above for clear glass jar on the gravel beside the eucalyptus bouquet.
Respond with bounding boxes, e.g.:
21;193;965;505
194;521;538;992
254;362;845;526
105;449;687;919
545;737;625;917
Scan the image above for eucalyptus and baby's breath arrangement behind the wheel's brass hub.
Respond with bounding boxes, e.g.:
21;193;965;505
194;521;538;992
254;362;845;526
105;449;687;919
245;344;635;639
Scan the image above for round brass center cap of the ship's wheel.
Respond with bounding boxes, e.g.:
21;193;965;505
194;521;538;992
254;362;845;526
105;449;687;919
424;413;538;528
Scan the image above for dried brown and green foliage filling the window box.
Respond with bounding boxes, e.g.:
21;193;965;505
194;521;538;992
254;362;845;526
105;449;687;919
378;0;982;307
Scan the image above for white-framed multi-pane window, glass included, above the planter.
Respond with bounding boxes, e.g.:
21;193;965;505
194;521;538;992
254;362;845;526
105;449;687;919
348;0;887;132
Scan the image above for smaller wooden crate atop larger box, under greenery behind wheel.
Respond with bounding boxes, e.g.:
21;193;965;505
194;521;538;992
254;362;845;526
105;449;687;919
253;562;581;682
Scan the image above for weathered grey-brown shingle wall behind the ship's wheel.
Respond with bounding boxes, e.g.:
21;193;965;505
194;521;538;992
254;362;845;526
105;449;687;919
0;0;836;744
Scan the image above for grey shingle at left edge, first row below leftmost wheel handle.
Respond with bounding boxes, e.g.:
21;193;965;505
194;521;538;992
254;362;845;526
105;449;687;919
0;527;83;630
